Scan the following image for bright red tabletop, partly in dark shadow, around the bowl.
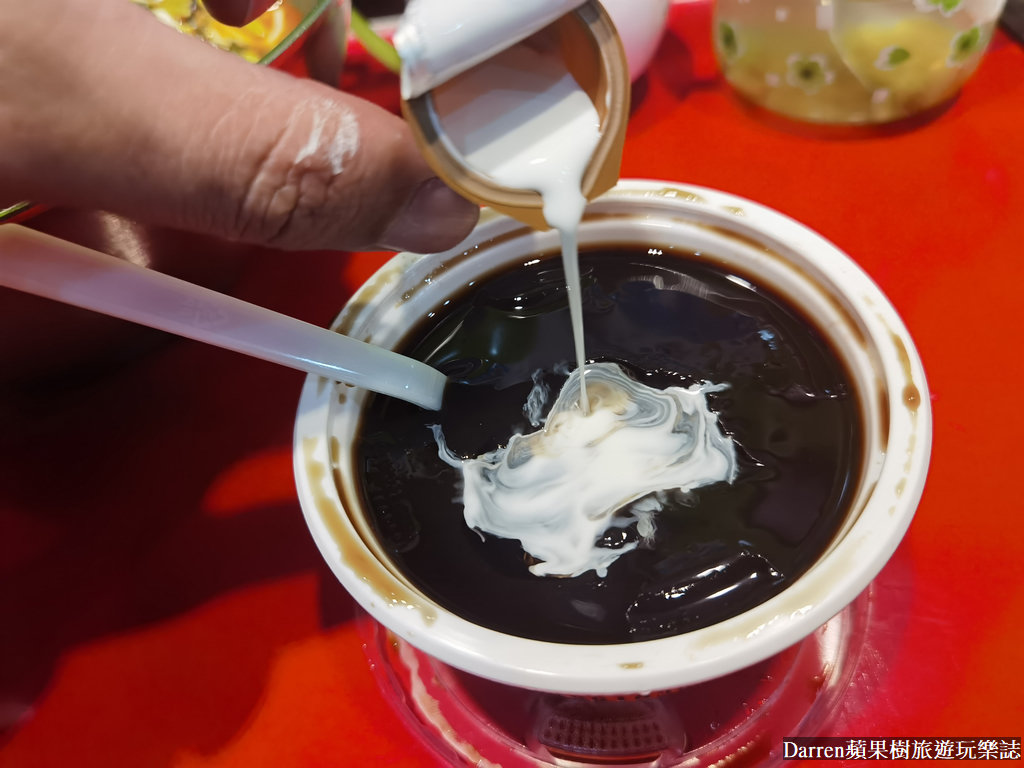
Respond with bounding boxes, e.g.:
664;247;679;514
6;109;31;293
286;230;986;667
0;3;1024;768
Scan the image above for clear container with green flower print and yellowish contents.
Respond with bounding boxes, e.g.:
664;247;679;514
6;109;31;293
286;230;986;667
714;0;1005;125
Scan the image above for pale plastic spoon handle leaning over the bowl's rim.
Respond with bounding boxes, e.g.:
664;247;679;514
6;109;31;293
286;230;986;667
0;224;445;410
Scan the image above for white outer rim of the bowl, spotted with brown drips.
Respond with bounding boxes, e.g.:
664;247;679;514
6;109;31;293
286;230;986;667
294;179;932;695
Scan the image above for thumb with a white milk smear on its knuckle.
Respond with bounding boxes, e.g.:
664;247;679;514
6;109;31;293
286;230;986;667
0;0;478;251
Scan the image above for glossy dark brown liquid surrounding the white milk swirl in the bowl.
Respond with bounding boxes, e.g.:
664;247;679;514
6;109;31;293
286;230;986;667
357;250;862;643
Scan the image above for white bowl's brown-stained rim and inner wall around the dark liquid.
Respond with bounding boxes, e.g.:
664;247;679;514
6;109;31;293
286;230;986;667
295;181;931;694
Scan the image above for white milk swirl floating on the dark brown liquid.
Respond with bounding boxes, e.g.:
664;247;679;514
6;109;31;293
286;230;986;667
434;362;736;577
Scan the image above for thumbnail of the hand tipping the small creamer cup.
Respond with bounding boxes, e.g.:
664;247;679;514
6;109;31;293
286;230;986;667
380;178;480;253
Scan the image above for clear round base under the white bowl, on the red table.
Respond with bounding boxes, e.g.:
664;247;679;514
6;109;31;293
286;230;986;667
358;585;877;768
